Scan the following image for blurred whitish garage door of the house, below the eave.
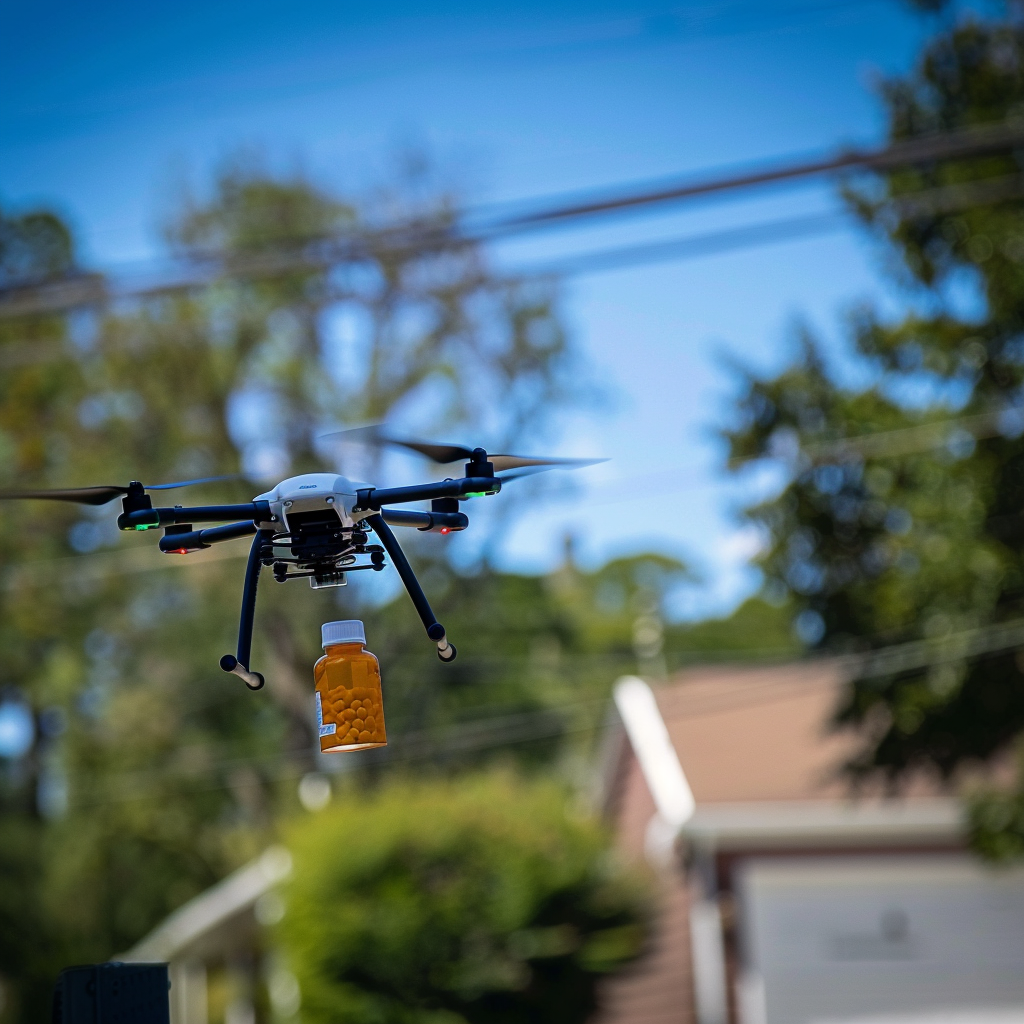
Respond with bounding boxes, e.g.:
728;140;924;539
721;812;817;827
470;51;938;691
737;855;1024;1024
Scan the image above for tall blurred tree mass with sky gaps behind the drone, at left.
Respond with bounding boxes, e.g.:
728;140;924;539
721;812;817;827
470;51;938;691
0;159;580;1021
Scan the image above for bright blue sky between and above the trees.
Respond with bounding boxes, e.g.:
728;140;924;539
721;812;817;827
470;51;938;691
0;0;942;615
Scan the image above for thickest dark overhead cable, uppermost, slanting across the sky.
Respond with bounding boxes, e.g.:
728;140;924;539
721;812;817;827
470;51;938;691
0;123;1024;317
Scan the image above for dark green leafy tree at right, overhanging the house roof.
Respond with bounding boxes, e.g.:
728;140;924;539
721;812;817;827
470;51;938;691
728;5;1024;821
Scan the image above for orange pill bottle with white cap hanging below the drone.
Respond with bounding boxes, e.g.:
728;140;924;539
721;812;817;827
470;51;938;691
313;618;387;754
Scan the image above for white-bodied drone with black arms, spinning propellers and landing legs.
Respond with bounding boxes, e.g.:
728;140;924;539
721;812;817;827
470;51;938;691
0;427;605;690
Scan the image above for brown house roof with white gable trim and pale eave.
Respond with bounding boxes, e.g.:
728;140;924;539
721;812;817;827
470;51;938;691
615;660;962;857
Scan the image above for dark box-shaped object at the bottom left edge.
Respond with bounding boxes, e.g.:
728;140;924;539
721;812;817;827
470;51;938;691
52;963;171;1024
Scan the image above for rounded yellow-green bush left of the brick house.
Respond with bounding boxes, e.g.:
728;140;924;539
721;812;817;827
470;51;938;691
280;774;646;1024
